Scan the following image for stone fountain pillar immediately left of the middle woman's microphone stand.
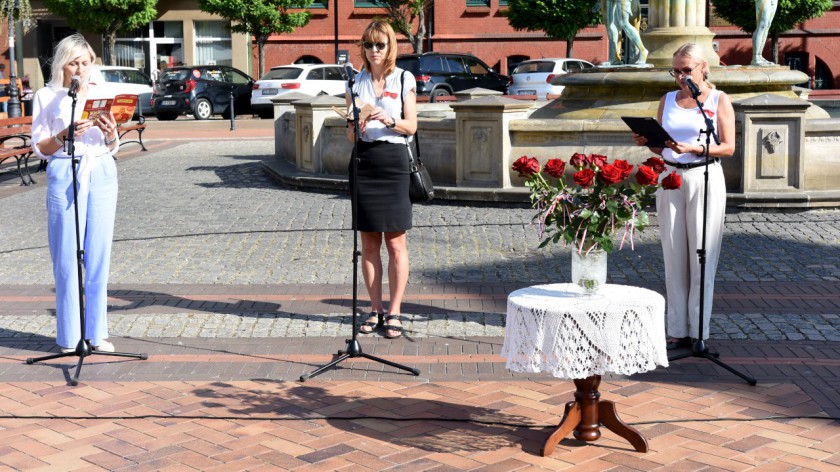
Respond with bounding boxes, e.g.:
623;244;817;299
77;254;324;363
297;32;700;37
294;95;347;174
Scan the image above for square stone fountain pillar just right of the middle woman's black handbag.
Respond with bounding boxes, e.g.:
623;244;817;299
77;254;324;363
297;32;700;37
450;96;532;188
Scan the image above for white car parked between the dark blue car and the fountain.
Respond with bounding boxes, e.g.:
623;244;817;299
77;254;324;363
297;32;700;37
508;59;595;100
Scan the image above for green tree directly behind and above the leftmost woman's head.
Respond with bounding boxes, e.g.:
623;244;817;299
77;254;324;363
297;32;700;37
44;0;157;65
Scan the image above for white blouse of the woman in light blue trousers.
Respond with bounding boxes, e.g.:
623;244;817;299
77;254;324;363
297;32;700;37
32;83;119;159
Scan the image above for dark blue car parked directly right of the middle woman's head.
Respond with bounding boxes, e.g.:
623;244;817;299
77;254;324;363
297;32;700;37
397;52;508;100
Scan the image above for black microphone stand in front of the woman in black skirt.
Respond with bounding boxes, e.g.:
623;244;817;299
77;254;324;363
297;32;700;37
300;69;420;382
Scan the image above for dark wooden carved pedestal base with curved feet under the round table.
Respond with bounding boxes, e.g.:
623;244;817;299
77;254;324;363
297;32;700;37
540;375;648;457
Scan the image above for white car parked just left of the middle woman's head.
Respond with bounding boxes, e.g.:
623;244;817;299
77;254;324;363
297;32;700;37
251;64;347;118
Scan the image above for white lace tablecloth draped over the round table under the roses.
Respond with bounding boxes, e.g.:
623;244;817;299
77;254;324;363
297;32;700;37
502;284;668;379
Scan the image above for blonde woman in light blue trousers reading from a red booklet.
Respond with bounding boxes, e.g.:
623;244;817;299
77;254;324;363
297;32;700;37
32;34;119;352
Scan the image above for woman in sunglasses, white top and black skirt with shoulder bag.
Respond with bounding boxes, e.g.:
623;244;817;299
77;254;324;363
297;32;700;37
346;21;417;338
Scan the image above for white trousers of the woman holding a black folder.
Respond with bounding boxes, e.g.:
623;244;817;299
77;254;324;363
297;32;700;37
656;163;726;339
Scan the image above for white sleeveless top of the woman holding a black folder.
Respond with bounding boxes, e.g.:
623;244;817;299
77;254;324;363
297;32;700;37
662;89;721;164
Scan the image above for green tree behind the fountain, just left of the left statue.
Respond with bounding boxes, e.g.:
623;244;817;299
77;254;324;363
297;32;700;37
505;0;601;57
